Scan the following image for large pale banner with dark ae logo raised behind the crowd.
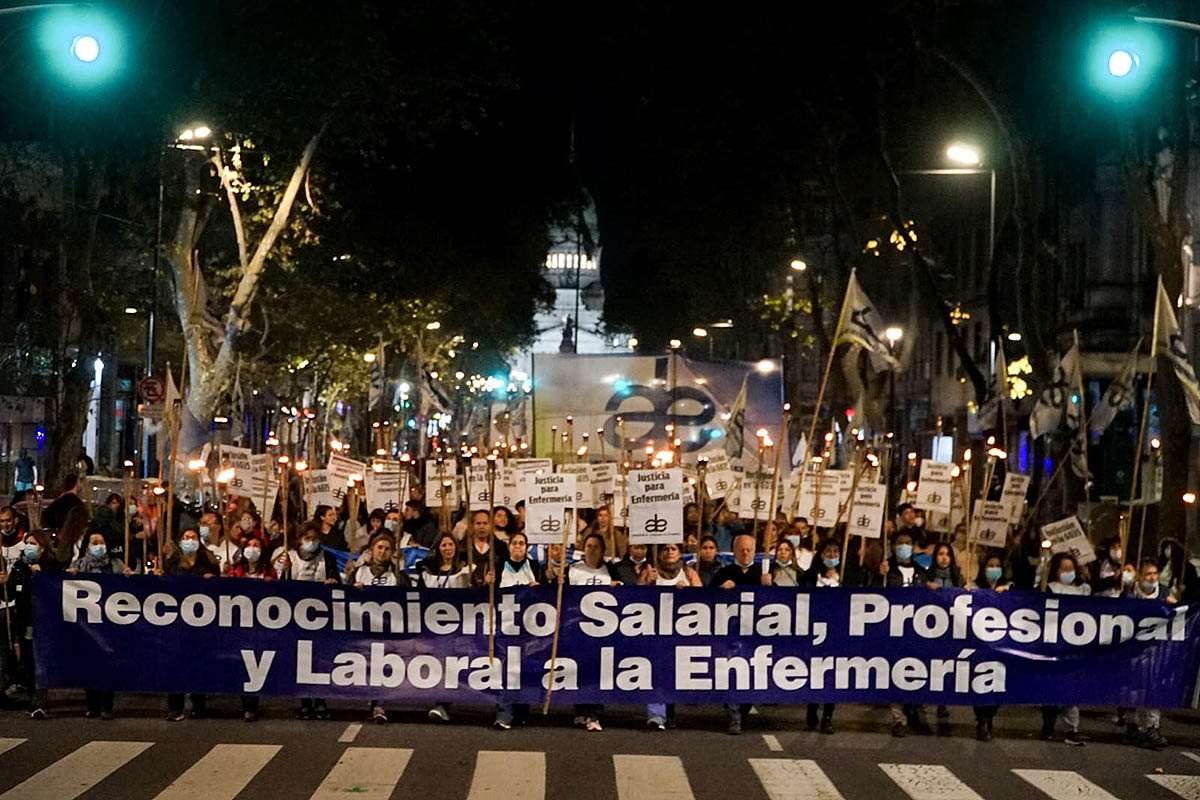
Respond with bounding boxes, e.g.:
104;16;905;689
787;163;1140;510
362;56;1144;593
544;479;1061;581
533;351;790;463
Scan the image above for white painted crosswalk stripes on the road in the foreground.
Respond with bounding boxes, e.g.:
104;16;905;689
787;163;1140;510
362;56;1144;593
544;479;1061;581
0;738;1200;800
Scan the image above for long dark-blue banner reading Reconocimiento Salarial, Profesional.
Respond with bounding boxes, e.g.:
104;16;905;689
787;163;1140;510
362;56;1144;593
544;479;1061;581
32;572;1200;708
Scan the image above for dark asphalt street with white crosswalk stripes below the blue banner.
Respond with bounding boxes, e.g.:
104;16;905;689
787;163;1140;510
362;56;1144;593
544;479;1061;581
0;693;1200;800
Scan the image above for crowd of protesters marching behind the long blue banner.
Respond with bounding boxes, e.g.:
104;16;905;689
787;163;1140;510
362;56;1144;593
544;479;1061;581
0;477;1185;748
